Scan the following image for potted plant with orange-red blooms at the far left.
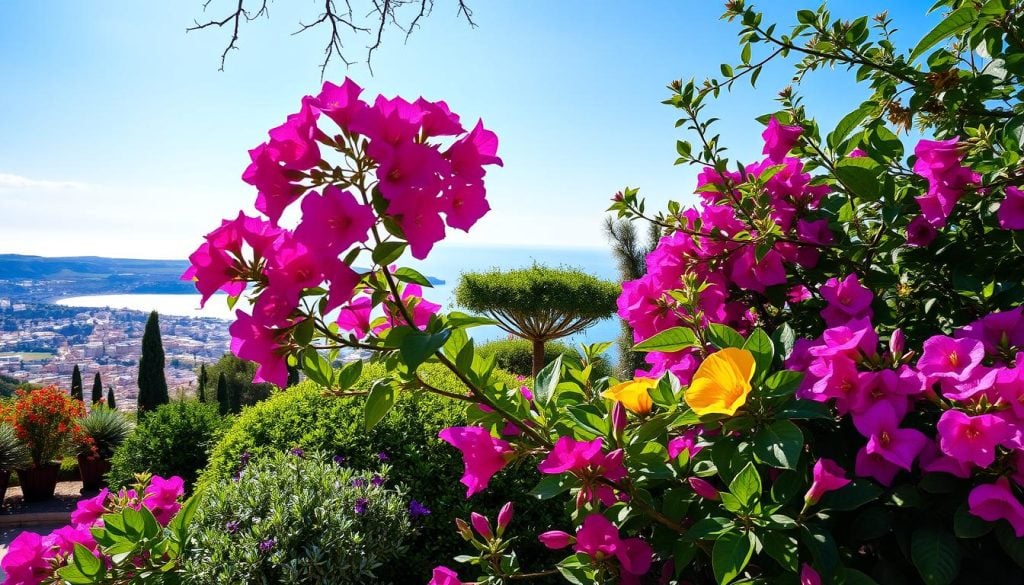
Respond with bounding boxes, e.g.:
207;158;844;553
10;386;88;502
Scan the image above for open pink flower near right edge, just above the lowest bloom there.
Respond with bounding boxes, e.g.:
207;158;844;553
935;410;1014;468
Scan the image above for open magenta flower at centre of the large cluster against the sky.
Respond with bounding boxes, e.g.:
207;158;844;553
295;185;377;257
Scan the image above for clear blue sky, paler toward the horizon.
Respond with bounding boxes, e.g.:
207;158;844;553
0;0;938;258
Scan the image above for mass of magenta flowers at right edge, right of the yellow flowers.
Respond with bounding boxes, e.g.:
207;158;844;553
787;275;1024;536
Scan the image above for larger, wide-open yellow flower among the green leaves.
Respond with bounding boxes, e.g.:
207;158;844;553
685;347;754;416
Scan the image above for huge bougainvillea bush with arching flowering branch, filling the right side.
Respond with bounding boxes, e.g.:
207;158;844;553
172;0;1024;585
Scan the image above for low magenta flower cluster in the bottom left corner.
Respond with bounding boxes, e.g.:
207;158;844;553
0;475;184;585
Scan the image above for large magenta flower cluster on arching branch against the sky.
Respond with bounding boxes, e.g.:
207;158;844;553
182;79;502;385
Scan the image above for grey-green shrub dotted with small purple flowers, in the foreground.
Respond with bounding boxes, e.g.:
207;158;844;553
185;452;412;585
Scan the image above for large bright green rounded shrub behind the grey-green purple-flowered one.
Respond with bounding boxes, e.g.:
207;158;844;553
199;364;568;583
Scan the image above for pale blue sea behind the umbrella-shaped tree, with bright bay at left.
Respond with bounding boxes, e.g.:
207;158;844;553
56;245;620;359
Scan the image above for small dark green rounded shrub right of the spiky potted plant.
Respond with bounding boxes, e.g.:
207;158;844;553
106;400;229;490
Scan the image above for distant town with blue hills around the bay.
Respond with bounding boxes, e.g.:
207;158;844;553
0;255;230;410
